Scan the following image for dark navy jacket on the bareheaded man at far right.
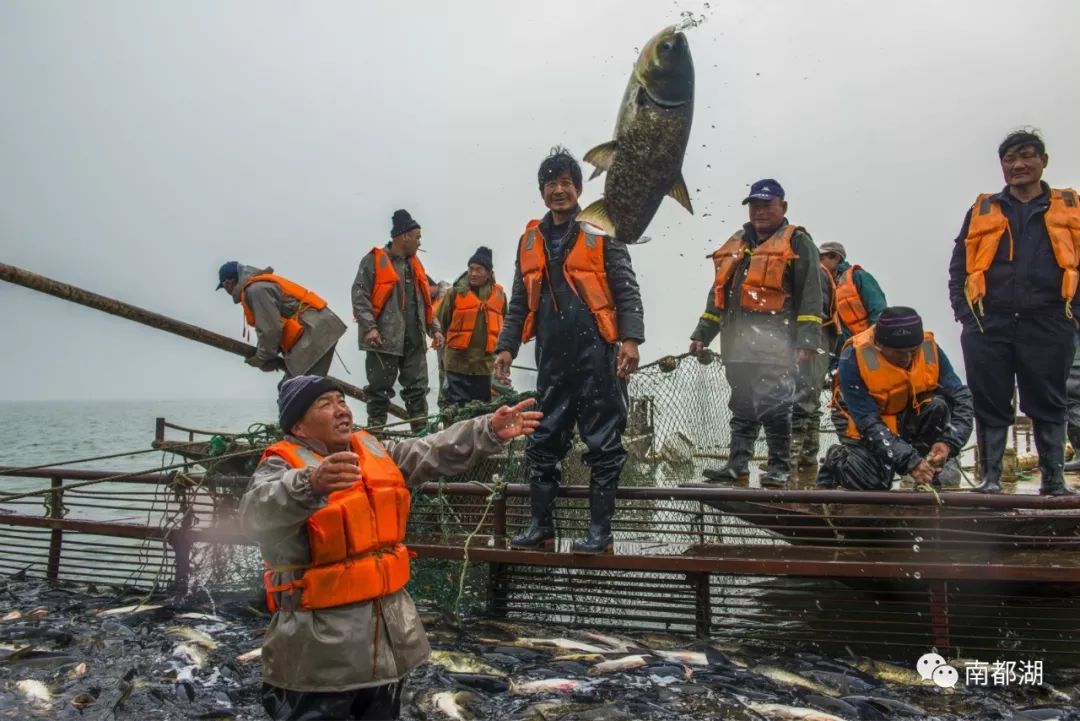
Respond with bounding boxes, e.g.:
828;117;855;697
948;182;1080;323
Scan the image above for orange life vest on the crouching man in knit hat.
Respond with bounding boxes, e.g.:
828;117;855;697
837;326;941;438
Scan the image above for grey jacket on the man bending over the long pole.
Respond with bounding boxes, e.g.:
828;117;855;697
232;266;347;376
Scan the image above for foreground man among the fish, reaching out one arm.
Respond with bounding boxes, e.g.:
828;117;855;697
240;376;541;721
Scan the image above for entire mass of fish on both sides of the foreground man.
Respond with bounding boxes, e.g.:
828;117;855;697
0;580;1080;721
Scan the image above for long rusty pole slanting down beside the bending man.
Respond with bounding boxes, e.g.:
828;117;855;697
0;263;408;419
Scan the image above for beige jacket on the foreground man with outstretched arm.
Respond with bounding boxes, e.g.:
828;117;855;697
240;416;502;692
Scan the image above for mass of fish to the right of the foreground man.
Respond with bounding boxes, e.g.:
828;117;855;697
403;621;1080;721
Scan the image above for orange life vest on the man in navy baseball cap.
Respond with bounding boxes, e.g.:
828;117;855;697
710;225;802;313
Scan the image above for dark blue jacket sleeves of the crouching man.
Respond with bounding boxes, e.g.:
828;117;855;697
839;345;975;473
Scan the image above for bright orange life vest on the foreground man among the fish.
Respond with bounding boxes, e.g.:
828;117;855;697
262;431;409;611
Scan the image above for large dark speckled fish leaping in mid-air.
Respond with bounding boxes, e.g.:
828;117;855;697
577;27;693;243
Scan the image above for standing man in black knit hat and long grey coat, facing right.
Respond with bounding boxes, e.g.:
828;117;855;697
352;210;443;432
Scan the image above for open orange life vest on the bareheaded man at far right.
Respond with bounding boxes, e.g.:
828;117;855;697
963;188;1080;315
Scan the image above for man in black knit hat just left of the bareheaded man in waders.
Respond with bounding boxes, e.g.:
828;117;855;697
437;245;507;406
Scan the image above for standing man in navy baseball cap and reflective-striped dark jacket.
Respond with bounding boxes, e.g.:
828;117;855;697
690;178;823;487
